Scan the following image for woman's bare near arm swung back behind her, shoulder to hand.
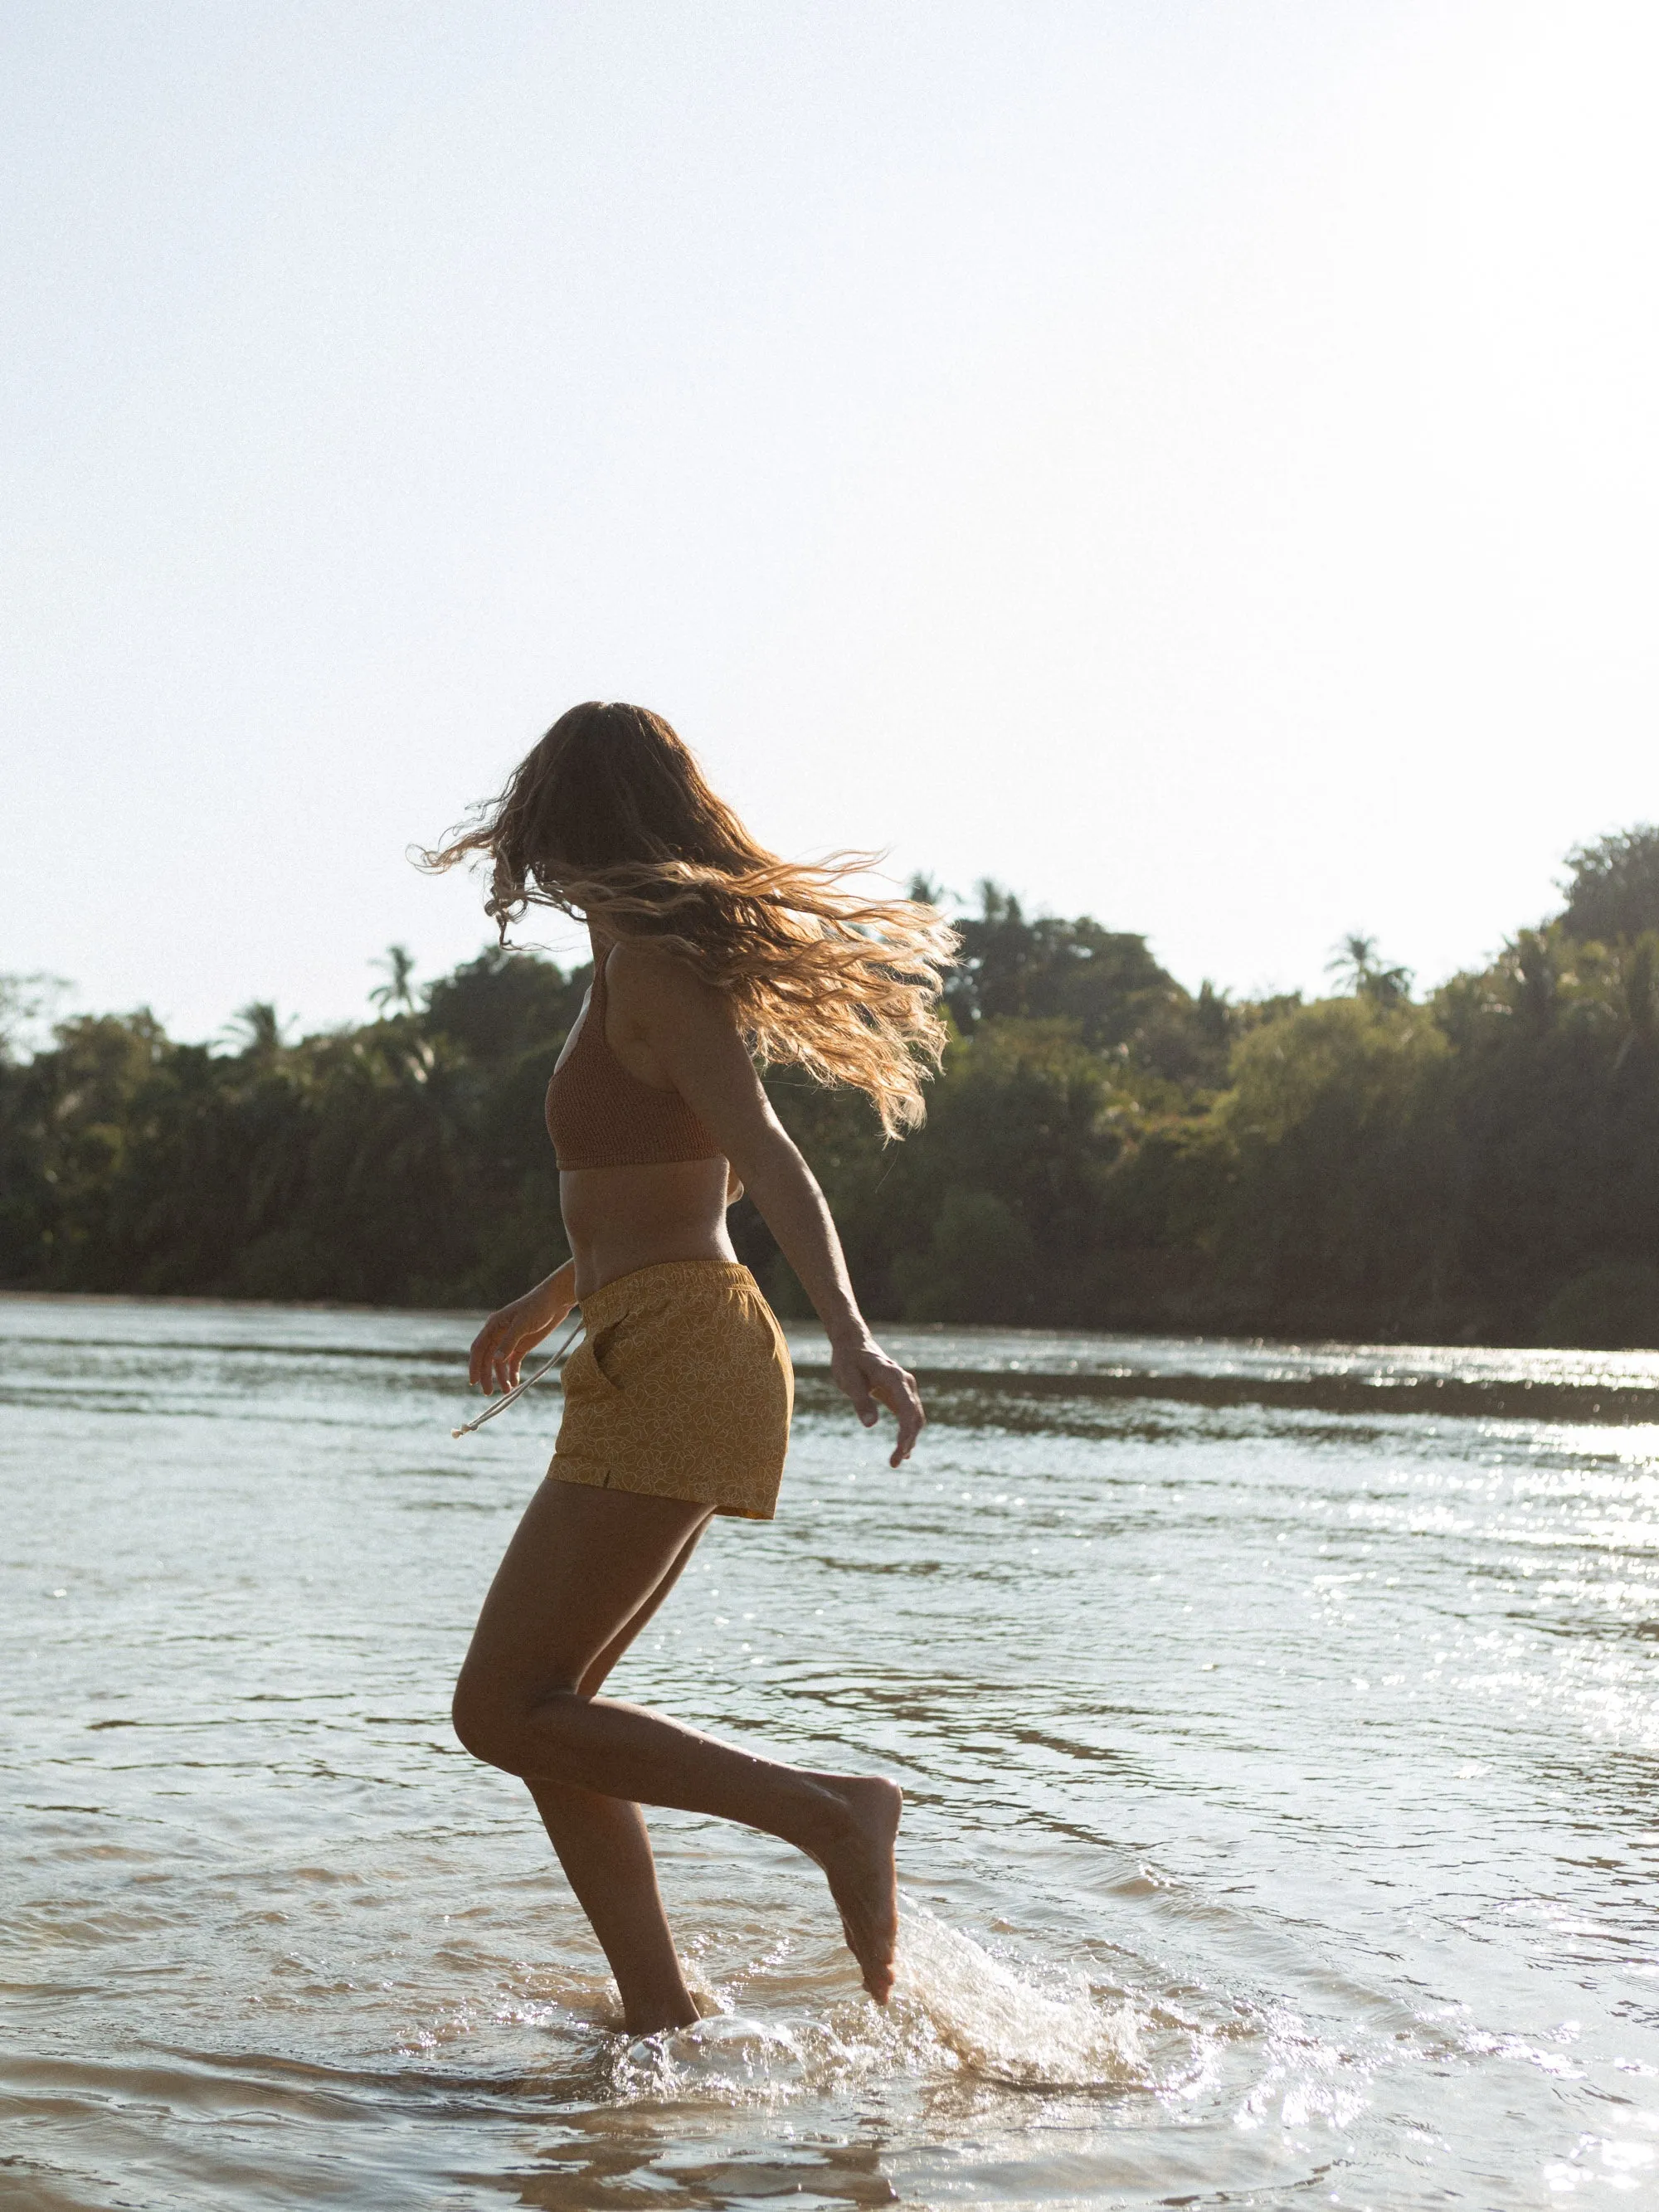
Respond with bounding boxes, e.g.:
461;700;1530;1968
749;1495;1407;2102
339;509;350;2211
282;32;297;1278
608;942;925;1466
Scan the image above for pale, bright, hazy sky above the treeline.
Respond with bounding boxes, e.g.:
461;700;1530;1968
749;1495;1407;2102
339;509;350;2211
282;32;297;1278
0;0;1659;1038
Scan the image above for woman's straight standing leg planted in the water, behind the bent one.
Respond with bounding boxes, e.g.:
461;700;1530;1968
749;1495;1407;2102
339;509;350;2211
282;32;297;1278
527;1518;708;2035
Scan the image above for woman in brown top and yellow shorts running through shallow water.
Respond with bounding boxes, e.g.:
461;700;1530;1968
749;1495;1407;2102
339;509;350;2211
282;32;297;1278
429;703;953;2035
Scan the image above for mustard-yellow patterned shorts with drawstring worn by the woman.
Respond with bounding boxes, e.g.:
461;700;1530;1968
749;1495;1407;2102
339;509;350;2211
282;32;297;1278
548;1259;794;1519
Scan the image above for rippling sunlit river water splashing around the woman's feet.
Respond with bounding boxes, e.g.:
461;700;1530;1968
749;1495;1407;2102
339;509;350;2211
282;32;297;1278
0;1299;1659;2212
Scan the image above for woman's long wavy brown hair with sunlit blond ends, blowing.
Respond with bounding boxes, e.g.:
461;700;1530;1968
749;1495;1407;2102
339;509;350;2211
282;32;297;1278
421;699;958;1137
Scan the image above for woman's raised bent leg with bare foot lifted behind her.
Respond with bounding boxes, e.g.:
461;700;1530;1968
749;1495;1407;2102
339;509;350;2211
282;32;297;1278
455;1480;900;2024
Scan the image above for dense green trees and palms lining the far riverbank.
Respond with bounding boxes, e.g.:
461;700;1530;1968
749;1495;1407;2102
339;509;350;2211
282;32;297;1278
0;829;1659;1345
